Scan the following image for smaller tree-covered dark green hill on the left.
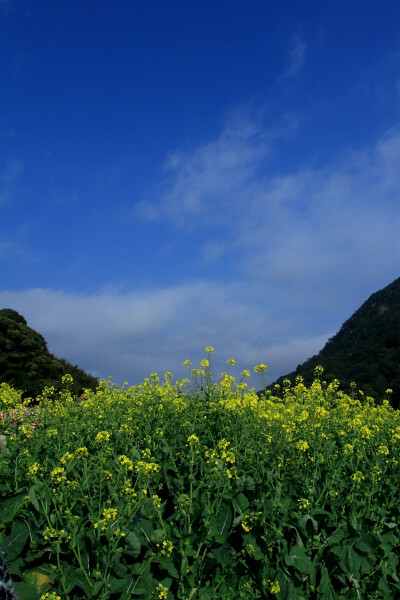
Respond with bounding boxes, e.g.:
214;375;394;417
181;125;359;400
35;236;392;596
0;308;98;397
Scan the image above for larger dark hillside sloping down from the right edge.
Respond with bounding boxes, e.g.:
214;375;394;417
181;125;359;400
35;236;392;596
269;277;400;408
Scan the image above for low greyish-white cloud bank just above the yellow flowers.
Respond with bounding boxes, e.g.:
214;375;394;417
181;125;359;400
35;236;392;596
0;281;329;386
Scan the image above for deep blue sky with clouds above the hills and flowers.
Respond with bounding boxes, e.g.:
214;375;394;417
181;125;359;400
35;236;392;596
0;0;400;387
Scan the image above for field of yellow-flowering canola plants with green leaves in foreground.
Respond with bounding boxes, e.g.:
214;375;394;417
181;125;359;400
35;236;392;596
0;347;400;600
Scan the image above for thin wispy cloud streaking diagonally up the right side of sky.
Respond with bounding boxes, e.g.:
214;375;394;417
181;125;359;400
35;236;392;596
139;106;400;314
